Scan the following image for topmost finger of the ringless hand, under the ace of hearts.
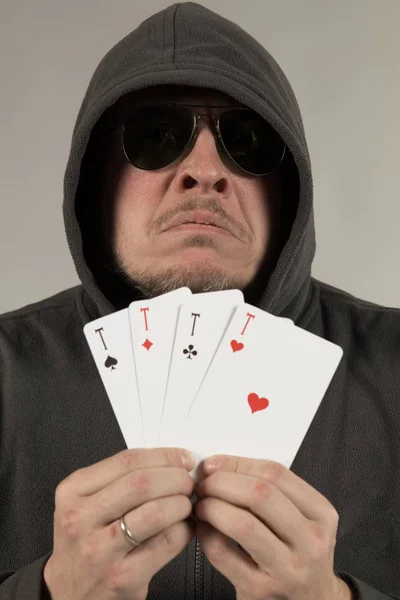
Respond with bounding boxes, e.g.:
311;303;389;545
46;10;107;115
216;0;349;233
203;454;337;522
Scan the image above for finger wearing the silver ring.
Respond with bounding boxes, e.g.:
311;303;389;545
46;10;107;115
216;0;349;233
108;496;192;554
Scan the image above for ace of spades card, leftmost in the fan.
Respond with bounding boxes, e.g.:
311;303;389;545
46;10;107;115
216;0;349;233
83;309;144;448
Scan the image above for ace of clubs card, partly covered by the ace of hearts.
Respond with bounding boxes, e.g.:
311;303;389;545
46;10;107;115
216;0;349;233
157;290;244;446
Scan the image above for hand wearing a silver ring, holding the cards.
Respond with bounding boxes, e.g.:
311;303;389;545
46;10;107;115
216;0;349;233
44;448;194;600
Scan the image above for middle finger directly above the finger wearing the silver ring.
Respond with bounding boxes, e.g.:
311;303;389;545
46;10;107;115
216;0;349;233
91;467;194;526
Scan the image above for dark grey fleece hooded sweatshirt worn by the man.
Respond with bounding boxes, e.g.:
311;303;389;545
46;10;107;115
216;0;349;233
0;2;400;600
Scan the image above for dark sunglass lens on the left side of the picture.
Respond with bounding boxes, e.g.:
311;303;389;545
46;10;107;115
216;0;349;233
123;107;193;170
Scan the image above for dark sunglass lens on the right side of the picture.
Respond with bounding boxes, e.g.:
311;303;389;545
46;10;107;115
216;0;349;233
220;110;285;175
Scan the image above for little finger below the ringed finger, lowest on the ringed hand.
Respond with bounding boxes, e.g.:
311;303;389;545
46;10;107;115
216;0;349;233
117;521;195;589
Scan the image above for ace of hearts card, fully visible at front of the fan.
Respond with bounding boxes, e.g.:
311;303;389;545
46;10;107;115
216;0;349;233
180;304;343;478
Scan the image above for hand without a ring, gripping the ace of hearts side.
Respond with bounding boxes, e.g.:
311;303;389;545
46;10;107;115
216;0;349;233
194;455;352;600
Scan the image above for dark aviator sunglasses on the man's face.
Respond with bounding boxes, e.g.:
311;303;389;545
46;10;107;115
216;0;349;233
101;104;286;176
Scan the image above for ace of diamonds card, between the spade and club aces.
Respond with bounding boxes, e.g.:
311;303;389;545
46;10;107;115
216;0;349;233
128;288;191;448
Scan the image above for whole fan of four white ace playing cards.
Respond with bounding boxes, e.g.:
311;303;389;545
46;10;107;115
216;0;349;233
84;288;343;477
